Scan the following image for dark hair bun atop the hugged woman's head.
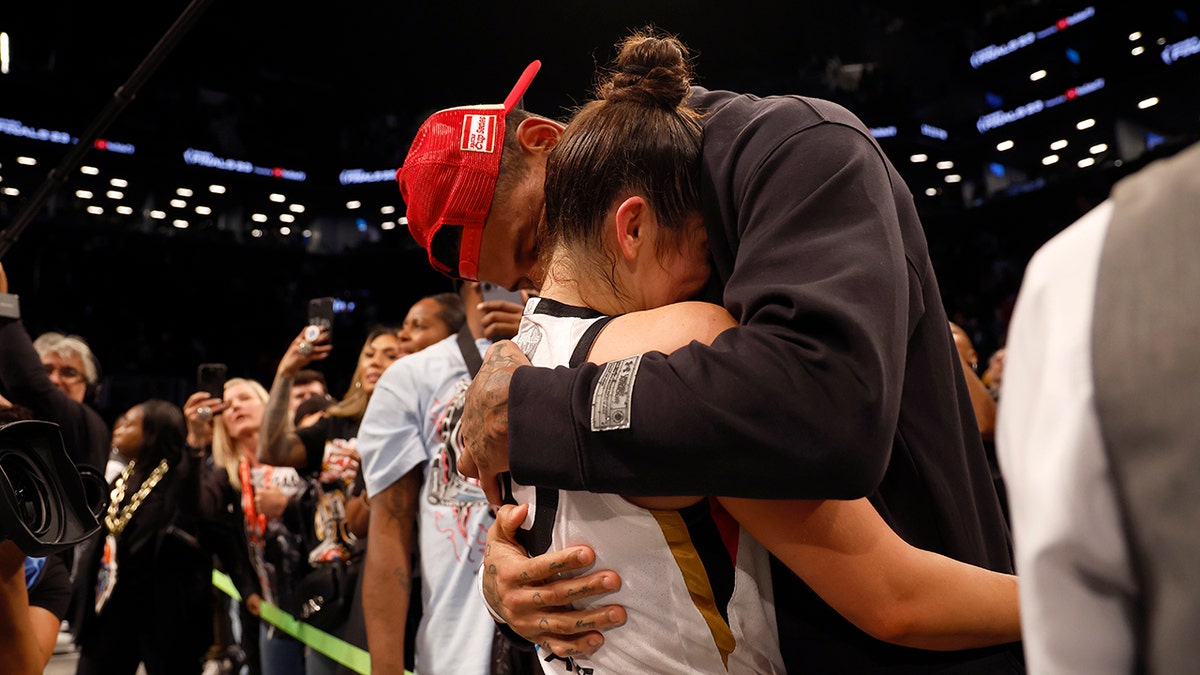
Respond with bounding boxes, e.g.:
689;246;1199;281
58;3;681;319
596;29;691;109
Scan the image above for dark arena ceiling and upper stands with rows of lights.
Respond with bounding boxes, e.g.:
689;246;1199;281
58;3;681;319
0;0;1200;403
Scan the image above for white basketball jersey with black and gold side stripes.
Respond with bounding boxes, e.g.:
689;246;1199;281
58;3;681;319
512;298;785;675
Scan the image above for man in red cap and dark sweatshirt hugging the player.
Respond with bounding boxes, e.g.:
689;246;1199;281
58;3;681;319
397;35;1021;673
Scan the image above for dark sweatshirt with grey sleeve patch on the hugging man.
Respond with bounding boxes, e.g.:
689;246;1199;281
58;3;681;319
509;89;1020;673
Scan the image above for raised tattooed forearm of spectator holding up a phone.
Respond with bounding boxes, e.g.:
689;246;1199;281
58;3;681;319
258;330;334;468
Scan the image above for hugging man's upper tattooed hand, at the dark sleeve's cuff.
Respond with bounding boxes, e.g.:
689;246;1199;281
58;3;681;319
458;340;529;504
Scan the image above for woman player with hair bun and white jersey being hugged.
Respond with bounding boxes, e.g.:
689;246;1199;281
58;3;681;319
501;32;1020;673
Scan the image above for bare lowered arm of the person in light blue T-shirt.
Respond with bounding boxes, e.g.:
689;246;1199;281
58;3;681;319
362;467;421;675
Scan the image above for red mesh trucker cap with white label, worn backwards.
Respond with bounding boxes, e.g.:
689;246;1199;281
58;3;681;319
396;61;541;281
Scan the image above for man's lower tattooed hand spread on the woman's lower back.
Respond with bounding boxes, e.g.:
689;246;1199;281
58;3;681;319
482;504;625;657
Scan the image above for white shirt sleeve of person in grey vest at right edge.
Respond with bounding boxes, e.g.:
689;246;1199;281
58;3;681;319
996;202;1135;675
